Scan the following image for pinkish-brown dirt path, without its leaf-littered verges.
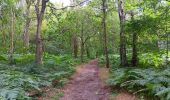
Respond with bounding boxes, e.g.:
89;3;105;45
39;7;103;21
60;60;109;100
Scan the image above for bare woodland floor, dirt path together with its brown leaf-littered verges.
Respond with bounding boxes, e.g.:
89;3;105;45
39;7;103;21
39;60;136;100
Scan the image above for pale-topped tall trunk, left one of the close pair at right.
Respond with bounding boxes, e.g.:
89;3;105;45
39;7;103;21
118;0;128;66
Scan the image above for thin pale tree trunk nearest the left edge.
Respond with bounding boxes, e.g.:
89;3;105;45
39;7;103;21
9;8;15;64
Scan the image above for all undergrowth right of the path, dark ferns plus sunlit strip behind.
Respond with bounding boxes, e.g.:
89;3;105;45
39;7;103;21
99;52;170;100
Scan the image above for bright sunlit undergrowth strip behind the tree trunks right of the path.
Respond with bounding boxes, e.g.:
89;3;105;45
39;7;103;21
99;51;170;69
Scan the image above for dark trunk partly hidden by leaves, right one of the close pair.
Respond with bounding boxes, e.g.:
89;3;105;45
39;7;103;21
131;12;138;67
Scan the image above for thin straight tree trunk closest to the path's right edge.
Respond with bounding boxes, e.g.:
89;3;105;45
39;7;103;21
102;0;110;68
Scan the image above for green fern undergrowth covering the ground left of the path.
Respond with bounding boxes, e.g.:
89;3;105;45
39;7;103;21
0;53;80;100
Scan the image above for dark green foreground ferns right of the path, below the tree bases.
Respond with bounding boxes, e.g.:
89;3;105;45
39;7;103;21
107;67;170;100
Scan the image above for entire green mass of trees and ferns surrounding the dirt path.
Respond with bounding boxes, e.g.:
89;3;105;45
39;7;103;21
0;0;170;100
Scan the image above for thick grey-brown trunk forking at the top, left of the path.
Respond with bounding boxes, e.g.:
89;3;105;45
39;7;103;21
35;0;49;65
